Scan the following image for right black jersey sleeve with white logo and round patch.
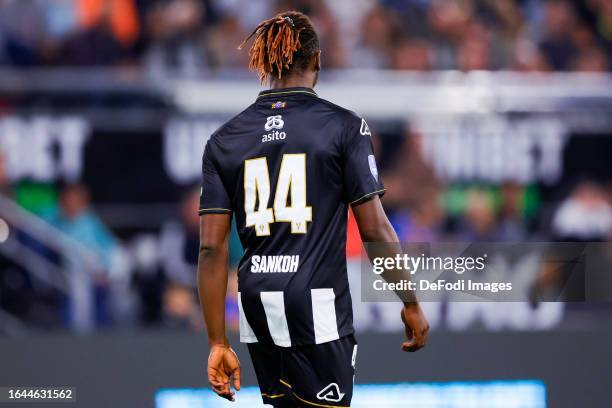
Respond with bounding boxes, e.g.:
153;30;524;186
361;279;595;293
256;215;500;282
343;117;385;205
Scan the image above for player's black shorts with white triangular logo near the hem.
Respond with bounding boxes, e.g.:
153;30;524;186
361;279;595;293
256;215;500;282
248;334;357;407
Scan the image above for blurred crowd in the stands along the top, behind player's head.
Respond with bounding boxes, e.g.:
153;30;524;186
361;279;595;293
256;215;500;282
0;0;612;75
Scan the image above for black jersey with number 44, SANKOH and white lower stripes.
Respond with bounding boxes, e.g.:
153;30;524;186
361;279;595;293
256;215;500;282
200;88;384;347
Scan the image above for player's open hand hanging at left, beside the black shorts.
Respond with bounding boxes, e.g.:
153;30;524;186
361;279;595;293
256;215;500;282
208;344;240;401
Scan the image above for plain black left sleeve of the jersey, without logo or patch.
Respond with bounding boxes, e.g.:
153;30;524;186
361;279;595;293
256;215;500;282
198;139;232;215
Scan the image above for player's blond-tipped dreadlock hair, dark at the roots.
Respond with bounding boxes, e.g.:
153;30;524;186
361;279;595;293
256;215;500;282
238;11;319;83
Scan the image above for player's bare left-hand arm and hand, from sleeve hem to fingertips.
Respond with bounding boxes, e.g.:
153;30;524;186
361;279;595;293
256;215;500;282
198;214;240;401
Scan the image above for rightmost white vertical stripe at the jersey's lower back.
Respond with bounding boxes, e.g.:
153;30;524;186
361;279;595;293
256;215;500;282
310;288;340;344
